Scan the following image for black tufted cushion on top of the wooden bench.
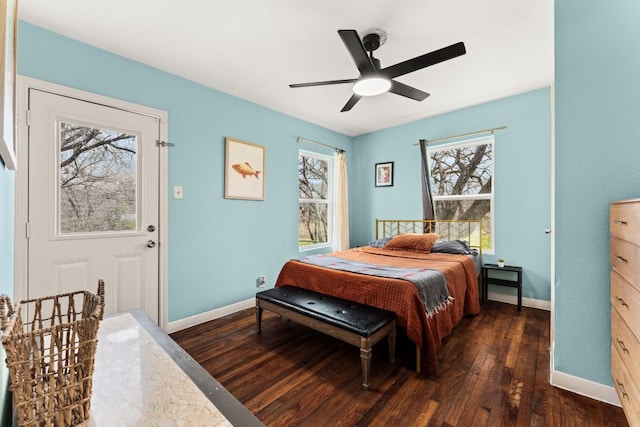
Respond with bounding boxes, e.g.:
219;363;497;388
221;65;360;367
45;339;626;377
256;286;396;337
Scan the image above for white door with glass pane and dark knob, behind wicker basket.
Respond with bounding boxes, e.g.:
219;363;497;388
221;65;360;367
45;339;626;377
27;89;160;323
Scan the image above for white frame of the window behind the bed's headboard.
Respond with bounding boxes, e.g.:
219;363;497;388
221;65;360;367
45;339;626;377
427;135;496;254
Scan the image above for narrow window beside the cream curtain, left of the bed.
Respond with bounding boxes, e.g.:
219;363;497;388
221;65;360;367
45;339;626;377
298;151;333;250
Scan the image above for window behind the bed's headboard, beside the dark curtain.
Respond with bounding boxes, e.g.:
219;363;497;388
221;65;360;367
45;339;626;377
427;136;494;253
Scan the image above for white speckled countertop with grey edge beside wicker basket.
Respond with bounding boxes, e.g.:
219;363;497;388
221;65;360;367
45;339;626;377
75;312;260;427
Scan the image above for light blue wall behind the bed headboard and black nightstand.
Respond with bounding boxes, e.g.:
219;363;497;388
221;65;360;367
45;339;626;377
349;88;551;301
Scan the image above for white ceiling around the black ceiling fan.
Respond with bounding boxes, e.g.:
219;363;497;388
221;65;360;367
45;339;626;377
19;0;553;136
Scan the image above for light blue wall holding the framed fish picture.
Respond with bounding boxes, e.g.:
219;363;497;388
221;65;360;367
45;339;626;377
18;22;352;321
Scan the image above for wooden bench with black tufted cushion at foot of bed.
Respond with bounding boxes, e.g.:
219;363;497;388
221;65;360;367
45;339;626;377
256;286;396;390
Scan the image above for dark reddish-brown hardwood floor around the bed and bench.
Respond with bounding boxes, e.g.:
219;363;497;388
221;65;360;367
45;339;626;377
171;301;628;427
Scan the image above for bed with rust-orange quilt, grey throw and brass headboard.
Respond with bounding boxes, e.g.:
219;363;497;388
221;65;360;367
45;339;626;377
275;220;482;375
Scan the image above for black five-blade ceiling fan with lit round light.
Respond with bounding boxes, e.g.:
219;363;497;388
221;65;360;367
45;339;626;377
289;30;467;112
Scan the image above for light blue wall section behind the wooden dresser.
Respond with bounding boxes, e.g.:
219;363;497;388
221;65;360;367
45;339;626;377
554;0;640;384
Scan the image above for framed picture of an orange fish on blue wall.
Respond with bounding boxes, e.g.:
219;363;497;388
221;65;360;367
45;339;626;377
224;137;266;200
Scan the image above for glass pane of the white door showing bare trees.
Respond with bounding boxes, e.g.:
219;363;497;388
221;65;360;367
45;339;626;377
59;123;137;234
